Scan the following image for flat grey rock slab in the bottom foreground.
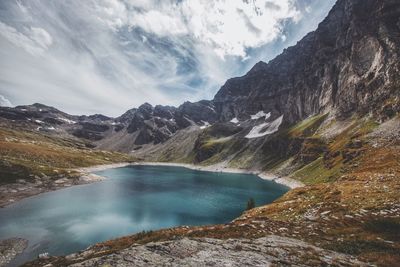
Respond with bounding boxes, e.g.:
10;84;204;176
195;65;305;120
71;235;368;267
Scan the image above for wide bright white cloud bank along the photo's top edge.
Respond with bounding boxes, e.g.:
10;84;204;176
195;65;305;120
95;0;300;58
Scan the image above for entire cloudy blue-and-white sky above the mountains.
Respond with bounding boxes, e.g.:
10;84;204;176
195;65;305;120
0;0;335;116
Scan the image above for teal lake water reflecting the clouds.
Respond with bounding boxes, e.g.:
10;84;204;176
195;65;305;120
0;166;288;264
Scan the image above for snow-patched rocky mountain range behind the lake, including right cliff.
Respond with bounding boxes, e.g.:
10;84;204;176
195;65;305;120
0;0;400;175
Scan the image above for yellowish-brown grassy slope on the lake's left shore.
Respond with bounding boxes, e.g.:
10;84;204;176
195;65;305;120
0;127;133;184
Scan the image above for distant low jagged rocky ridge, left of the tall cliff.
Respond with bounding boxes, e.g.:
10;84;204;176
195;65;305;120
0;101;218;152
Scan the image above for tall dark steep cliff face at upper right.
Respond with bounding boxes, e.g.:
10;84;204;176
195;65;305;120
214;0;400;123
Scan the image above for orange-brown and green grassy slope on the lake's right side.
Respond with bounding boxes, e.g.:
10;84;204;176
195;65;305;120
20;115;400;266
